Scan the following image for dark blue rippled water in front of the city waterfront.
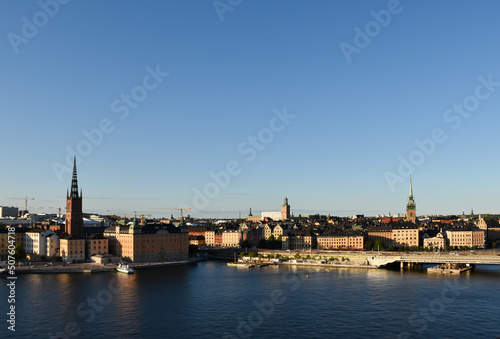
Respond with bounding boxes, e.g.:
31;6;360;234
0;261;500;338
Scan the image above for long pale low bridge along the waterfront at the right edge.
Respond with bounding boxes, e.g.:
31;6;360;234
367;253;500;267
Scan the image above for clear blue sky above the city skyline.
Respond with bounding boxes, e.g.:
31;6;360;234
0;0;500;218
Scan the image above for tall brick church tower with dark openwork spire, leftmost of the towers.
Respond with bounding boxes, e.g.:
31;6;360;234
64;155;84;238
